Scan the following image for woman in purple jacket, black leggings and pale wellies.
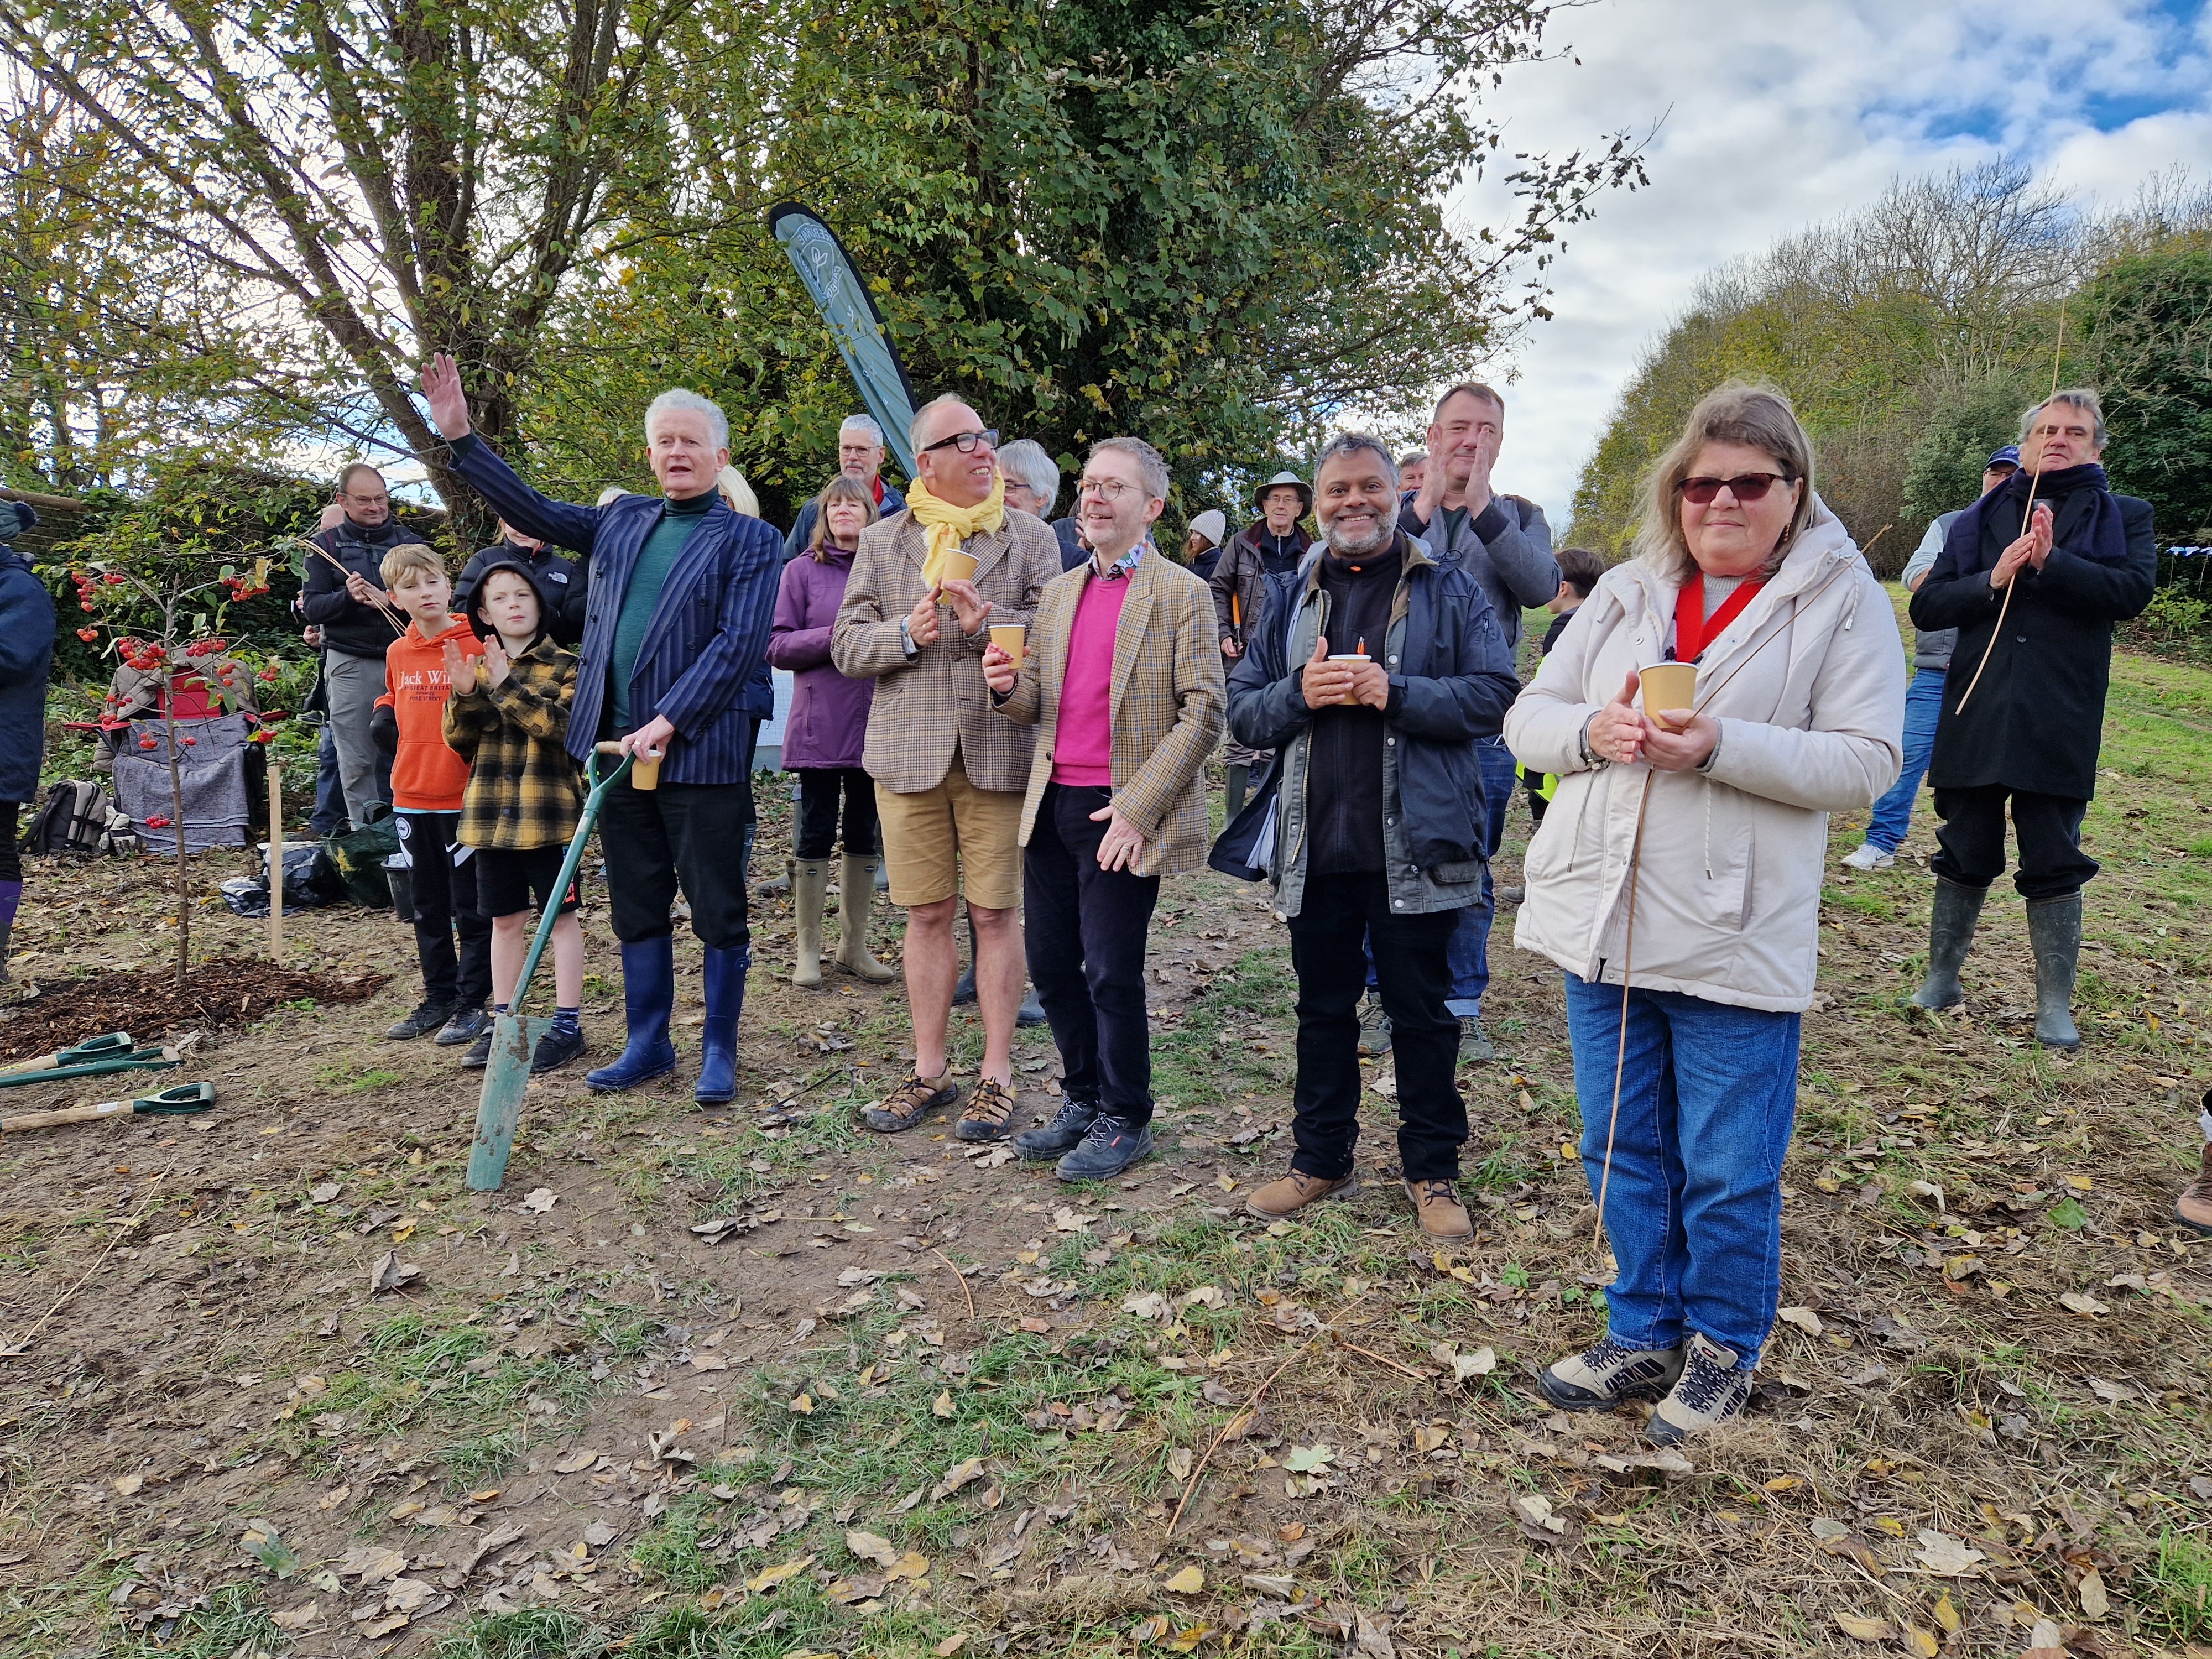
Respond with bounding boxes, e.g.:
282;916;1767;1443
768;473;891;989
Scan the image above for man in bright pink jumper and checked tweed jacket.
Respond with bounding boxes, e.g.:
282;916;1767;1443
982;438;1223;1181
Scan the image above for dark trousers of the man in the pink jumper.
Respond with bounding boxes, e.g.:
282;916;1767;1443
1022;783;1159;1124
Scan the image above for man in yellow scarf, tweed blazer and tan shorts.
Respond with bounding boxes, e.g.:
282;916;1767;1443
830;394;1060;1141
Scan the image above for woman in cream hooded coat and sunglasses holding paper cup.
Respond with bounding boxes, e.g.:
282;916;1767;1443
1506;385;1905;1442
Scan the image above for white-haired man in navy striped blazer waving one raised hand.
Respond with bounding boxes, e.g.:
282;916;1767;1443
422;352;783;1102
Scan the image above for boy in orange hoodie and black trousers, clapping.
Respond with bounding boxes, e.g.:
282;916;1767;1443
374;542;491;1046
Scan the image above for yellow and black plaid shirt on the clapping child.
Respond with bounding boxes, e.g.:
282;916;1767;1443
445;635;584;852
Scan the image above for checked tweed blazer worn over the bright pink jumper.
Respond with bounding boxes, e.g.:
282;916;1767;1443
998;549;1223;876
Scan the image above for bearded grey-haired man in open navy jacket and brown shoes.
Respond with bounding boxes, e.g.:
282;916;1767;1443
1212;434;1520;1243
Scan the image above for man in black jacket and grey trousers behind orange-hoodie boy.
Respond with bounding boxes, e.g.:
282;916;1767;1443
299;460;422;825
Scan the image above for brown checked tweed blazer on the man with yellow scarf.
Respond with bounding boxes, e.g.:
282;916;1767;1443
830;507;1060;794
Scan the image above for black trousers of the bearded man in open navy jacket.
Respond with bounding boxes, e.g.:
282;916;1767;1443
1290;872;1467;1181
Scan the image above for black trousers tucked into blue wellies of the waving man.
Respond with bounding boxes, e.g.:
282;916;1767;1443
599;779;752;951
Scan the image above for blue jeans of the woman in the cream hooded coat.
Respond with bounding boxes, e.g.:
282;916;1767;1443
1566;973;1801;1369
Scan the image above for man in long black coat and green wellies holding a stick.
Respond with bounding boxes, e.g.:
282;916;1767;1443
1911;389;2159;1048
